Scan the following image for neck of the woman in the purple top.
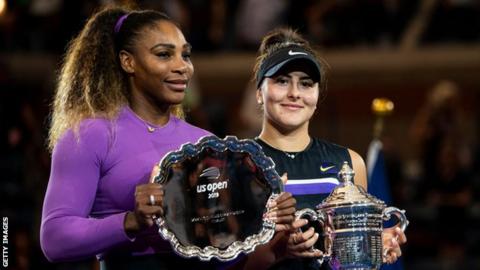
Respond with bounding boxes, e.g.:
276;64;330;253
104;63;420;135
129;93;170;126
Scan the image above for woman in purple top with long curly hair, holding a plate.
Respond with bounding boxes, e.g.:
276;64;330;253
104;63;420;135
41;8;295;269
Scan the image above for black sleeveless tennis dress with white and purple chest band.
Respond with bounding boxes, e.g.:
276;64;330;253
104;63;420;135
255;137;352;270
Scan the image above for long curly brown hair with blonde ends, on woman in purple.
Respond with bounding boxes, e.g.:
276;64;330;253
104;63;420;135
48;7;184;150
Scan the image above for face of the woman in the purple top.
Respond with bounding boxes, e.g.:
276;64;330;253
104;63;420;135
120;20;193;108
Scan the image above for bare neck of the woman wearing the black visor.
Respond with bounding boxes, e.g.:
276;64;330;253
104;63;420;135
258;119;310;152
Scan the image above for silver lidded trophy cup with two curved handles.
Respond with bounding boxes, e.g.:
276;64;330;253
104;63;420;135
295;162;408;270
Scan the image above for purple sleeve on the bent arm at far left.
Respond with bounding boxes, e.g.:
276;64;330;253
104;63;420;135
40;125;129;262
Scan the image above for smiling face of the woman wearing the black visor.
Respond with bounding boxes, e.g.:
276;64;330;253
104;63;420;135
257;71;319;131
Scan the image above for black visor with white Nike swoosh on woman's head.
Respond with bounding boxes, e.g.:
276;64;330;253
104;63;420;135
256;45;320;89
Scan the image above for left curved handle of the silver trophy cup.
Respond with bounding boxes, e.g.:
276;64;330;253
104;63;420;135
295;208;333;264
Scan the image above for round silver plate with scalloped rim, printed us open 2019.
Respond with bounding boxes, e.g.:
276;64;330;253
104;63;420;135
154;135;283;261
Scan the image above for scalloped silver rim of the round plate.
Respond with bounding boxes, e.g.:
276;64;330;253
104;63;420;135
154;135;283;261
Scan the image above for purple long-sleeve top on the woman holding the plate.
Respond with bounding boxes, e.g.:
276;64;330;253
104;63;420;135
40;107;210;261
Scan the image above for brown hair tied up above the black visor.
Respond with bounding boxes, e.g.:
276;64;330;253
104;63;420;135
253;28;330;98
